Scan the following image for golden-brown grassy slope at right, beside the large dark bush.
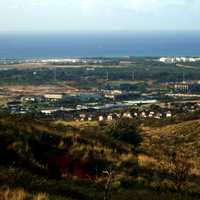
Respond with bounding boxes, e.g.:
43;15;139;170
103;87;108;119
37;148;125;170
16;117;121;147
141;120;200;193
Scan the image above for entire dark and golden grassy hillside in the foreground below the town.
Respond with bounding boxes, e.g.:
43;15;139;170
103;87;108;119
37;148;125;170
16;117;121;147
0;114;200;200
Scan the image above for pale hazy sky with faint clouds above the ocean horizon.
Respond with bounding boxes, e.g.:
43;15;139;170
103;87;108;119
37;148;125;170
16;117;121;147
0;0;200;31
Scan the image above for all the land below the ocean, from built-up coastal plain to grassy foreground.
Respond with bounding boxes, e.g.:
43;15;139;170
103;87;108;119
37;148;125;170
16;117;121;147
0;57;200;200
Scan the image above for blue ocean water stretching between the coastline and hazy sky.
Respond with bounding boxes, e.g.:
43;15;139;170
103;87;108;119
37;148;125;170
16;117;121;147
0;32;200;59
